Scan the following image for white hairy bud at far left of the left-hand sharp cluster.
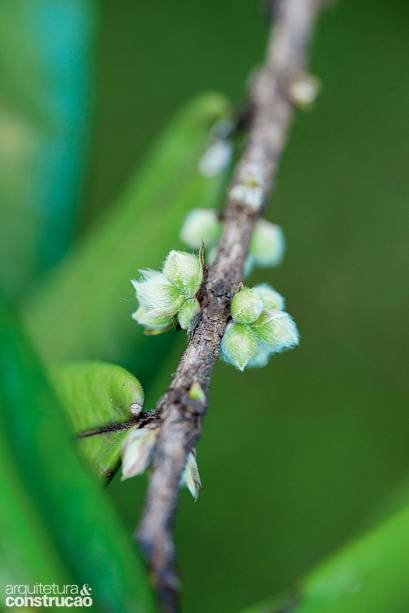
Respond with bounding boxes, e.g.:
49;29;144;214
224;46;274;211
132;270;184;317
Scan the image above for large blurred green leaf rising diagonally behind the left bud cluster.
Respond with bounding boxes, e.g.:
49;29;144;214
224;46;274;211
24;94;229;378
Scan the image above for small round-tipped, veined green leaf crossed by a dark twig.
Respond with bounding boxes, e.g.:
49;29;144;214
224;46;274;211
53;362;143;479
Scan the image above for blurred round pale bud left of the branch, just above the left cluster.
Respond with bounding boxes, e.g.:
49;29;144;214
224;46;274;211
180;209;222;249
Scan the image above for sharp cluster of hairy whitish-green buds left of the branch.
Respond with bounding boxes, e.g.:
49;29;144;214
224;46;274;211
132;251;203;333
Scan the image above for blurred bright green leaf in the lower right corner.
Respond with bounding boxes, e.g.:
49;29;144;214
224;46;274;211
245;507;409;613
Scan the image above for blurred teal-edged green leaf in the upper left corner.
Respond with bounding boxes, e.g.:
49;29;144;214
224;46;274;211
0;0;96;295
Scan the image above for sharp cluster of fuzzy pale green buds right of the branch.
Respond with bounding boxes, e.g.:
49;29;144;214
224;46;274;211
221;284;299;370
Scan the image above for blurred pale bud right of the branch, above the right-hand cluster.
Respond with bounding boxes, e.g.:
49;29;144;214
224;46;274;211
249;219;285;268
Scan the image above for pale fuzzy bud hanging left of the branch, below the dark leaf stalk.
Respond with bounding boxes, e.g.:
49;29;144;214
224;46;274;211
122;427;159;480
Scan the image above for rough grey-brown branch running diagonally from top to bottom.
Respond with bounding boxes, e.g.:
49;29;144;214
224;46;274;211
137;0;320;611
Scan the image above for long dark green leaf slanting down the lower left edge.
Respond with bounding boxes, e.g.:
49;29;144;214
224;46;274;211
0;302;152;612
